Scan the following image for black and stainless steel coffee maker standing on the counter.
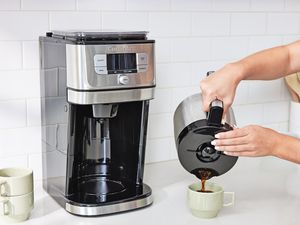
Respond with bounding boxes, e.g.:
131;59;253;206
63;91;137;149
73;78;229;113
39;31;155;216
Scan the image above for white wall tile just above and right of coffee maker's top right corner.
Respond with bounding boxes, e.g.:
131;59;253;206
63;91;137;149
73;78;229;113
149;12;191;37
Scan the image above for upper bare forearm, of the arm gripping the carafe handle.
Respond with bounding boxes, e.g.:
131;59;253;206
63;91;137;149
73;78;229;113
230;41;300;82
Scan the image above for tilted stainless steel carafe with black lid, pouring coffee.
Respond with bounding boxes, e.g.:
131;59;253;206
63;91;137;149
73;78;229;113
174;72;238;179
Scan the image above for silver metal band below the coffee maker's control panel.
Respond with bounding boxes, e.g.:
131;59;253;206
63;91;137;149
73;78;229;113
68;87;154;105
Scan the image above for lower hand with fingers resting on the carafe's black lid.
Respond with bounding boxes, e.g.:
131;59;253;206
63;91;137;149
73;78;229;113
211;125;281;157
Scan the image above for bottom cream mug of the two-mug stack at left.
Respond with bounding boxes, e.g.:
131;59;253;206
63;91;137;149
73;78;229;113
0;192;34;222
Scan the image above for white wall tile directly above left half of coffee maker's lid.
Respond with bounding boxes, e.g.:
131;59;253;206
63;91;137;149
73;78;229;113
50;12;101;30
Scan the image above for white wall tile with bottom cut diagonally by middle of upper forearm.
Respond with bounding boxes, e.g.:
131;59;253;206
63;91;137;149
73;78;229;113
248;36;282;54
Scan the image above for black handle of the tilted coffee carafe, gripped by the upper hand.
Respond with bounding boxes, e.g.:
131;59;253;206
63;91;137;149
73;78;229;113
206;71;224;126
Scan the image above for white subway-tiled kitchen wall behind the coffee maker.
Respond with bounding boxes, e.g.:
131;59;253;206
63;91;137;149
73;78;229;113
0;0;300;178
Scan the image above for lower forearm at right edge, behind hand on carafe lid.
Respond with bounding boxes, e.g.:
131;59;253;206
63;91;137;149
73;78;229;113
273;134;300;164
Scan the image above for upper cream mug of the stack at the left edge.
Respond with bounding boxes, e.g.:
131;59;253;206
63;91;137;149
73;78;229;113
0;168;33;197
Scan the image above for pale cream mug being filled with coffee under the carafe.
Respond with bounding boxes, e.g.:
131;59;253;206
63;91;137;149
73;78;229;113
187;182;234;218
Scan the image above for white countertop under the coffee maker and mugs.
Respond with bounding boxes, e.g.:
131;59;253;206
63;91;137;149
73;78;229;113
7;158;300;225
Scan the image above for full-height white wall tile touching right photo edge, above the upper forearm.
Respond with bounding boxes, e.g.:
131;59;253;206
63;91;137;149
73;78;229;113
267;13;300;35
